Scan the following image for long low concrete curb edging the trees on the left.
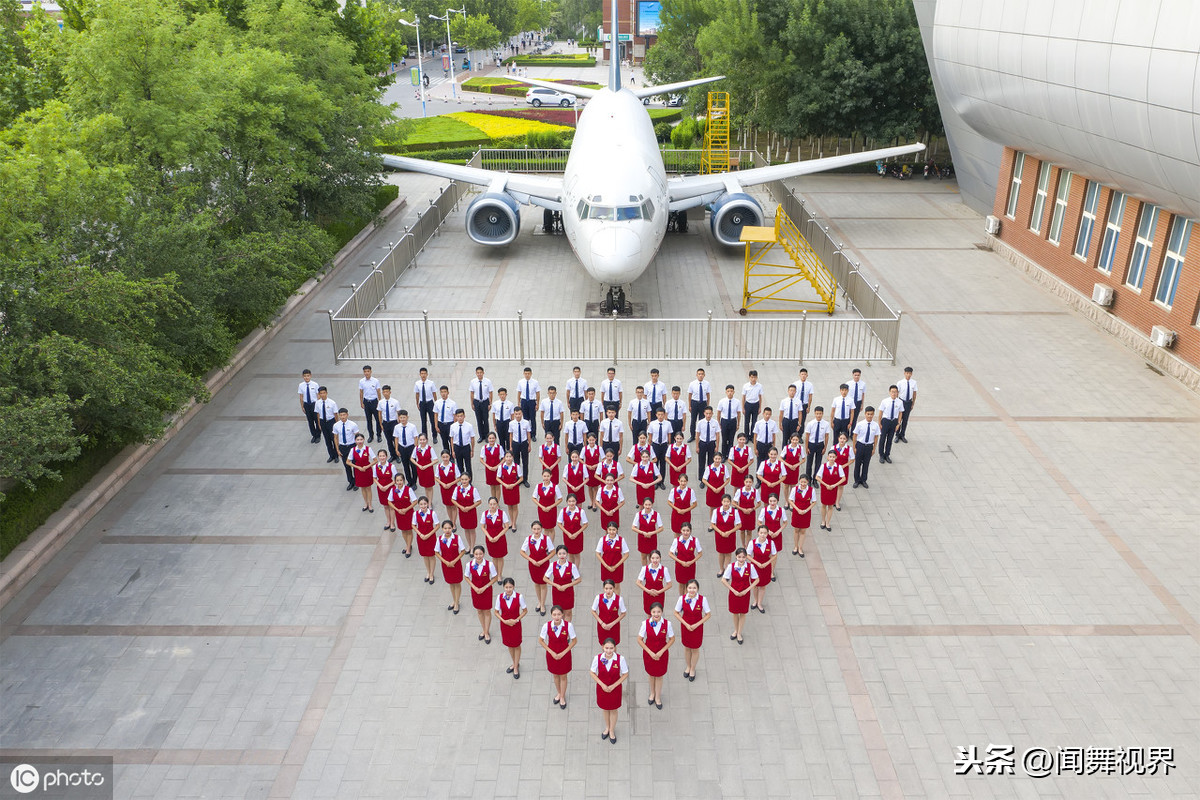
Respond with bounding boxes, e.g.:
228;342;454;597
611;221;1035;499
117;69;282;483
0;197;408;607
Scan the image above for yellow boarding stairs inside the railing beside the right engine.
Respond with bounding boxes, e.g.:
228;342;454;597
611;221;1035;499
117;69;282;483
739;207;838;315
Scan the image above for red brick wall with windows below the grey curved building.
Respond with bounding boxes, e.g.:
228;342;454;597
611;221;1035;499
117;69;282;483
992;148;1200;366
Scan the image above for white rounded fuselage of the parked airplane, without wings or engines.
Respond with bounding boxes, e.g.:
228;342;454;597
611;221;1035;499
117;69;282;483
563;89;668;285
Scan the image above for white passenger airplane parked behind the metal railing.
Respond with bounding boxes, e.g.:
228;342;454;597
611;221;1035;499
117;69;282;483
383;2;925;313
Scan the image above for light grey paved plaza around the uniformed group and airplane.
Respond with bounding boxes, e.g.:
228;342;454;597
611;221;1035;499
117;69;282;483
0;175;1200;800
